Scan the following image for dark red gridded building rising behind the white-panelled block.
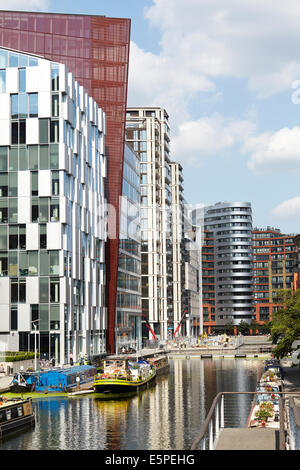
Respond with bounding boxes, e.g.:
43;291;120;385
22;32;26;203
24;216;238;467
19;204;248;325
0;11;130;352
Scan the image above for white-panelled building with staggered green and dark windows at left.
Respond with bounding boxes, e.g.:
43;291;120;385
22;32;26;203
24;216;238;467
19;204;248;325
0;48;107;363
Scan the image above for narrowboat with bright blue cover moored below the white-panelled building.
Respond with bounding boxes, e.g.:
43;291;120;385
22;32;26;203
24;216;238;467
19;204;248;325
10;365;97;393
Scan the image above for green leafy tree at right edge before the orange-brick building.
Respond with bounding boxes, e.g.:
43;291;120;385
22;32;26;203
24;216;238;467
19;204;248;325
270;289;300;359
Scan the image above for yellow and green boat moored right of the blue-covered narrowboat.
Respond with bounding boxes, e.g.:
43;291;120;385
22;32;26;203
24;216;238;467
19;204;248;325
93;358;156;393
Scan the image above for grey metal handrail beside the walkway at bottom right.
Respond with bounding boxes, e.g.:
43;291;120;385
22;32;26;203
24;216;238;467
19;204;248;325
191;391;300;450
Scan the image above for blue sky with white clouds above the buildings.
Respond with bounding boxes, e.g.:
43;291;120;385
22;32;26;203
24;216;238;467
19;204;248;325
0;0;300;233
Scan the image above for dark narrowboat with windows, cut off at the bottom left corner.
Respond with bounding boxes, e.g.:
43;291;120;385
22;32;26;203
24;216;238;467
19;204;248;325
0;397;35;439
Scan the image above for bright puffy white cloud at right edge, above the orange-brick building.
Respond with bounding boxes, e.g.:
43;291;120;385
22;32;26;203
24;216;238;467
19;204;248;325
244;126;300;172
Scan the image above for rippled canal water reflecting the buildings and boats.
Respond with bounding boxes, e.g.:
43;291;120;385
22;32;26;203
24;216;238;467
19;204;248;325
0;357;263;450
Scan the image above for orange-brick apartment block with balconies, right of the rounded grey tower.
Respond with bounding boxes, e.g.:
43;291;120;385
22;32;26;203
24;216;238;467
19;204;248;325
253;227;298;323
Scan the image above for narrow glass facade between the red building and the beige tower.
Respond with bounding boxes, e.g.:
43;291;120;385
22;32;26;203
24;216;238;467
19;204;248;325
116;144;142;351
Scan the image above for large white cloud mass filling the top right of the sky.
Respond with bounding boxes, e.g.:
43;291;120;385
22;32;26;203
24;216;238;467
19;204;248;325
129;0;300;116
